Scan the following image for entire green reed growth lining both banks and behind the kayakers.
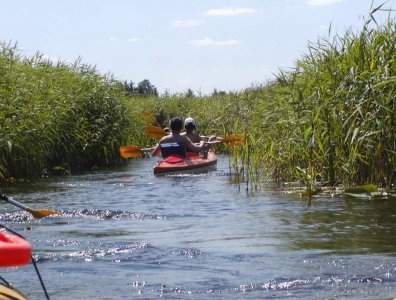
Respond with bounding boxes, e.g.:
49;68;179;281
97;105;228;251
0;9;396;192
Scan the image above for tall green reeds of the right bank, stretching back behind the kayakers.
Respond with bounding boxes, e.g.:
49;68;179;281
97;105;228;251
125;6;396;193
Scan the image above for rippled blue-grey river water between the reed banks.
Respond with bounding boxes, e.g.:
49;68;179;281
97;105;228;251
0;156;396;299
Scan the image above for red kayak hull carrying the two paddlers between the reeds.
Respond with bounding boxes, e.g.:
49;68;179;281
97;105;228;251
154;150;217;175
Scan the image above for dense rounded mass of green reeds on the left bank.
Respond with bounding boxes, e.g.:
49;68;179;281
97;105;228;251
0;44;130;180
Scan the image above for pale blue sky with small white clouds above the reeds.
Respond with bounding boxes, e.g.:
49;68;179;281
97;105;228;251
0;0;396;94
